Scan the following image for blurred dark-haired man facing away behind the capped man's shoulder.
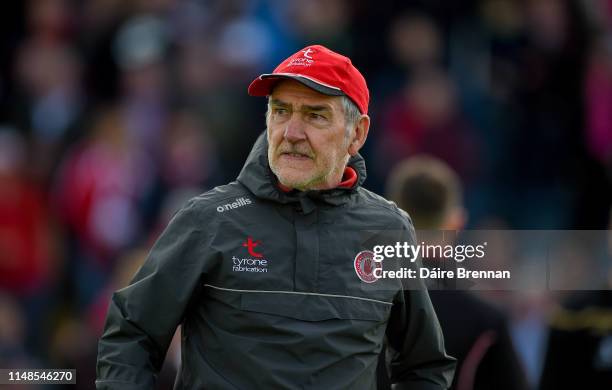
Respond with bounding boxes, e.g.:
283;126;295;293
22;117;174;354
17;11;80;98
379;155;528;390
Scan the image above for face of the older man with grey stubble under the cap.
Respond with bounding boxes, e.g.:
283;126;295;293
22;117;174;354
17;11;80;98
266;80;349;190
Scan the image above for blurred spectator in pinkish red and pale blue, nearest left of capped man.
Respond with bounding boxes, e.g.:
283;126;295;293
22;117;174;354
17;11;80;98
54;107;153;307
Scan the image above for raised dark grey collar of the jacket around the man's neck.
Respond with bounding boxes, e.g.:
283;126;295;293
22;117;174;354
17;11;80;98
238;131;366;213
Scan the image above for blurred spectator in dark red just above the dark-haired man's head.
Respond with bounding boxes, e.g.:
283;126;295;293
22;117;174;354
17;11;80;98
376;68;480;192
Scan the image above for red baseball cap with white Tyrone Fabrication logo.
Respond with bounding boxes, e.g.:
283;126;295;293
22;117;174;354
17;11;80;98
249;45;370;114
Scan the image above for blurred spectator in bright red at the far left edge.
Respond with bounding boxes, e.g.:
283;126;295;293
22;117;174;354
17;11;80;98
0;126;63;351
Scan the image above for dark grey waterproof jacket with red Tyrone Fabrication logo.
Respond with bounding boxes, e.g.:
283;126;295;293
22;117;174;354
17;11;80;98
96;133;454;390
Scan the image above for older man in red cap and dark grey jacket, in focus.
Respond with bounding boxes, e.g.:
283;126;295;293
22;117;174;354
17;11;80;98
96;45;454;389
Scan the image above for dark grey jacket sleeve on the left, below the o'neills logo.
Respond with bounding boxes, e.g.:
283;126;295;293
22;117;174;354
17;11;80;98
96;201;210;389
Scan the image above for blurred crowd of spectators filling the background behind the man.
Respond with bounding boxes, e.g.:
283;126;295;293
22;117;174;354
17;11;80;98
0;0;612;388
